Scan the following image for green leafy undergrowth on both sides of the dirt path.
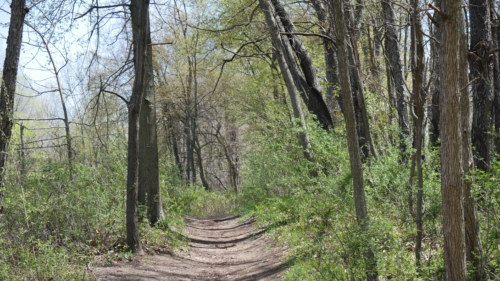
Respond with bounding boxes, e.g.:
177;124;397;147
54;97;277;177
0;116;500;281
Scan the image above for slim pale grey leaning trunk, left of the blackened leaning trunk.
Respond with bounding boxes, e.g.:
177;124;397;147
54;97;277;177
259;0;316;163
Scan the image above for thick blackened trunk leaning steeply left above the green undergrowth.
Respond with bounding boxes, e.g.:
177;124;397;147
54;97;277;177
271;0;333;130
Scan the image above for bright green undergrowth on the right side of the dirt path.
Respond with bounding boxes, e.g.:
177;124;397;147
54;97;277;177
236;122;443;281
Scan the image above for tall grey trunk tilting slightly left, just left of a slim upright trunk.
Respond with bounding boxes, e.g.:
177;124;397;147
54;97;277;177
382;0;410;164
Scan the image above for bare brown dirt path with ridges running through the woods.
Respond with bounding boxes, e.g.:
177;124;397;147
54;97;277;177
92;216;286;281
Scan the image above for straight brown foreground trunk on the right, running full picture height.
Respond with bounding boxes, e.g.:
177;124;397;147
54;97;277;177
440;1;467;281
